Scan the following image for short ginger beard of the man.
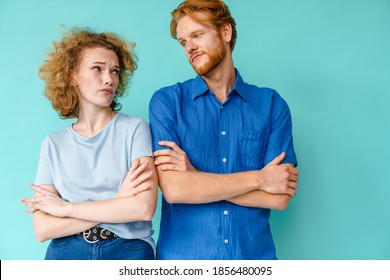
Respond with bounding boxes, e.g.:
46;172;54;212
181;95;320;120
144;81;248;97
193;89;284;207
191;36;226;76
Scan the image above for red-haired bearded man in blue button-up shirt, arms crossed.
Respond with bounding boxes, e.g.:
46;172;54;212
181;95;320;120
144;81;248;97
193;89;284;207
149;0;298;259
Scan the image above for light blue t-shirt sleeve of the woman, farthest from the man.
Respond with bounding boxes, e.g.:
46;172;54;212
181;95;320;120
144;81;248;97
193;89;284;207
35;137;54;186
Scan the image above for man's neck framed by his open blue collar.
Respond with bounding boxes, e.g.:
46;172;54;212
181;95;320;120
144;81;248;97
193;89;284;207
202;56;236;103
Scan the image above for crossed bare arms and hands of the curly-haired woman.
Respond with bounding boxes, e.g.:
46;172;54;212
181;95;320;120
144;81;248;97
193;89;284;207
22;157;158;242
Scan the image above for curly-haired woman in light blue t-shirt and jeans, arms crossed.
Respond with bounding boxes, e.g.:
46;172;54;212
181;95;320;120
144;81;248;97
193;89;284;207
22;29;158;259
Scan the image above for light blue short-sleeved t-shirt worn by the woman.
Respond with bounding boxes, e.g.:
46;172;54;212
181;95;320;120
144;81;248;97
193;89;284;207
35;113;155;248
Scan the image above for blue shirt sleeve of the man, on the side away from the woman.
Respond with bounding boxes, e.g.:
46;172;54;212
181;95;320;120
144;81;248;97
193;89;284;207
264;93;298;166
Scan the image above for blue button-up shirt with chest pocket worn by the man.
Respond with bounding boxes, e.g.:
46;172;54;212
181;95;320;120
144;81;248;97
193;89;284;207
149;70;297;260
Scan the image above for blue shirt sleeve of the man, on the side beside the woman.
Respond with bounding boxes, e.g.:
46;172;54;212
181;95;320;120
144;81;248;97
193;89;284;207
149;90;182;151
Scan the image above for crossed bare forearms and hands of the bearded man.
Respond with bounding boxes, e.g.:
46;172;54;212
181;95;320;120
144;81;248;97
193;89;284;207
154;141;298;210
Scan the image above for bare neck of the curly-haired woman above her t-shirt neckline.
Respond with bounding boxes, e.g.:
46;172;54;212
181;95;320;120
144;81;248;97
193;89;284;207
73;108;116;137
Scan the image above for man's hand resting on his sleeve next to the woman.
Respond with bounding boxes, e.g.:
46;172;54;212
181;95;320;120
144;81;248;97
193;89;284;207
153;141;197;171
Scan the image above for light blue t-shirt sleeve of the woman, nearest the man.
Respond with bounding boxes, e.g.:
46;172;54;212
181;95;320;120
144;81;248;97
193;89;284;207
130;119;152;162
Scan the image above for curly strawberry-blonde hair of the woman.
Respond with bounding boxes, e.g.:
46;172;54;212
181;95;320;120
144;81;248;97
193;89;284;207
38;28;137;119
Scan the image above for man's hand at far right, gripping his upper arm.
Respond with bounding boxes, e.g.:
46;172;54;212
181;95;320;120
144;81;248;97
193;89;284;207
259;153;298;197
